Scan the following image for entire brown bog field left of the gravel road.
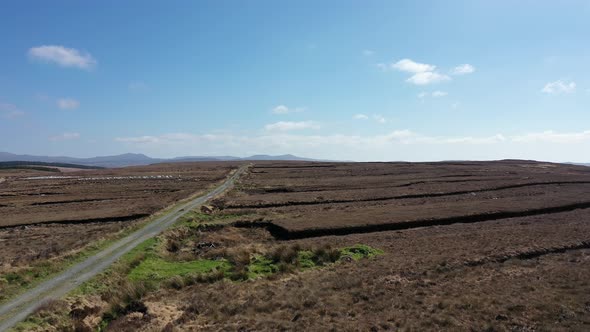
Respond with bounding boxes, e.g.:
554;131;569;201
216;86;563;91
0;162;237;271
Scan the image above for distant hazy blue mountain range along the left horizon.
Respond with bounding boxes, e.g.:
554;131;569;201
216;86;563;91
0;152;318;167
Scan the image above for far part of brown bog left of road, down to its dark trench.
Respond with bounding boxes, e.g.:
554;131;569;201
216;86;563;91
0;163;240;227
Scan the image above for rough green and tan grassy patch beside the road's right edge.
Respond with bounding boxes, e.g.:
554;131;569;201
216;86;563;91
13;204;383;331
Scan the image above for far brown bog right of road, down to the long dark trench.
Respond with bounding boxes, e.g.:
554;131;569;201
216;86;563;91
225;161;590;238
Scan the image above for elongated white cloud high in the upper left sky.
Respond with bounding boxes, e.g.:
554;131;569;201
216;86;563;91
28;45;96;69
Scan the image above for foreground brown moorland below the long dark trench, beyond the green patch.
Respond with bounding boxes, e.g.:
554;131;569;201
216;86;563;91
121;210;590;331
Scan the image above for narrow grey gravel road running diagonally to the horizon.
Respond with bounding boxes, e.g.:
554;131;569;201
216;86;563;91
0;165;248;331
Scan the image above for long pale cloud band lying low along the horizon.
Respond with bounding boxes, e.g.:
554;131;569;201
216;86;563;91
115;129;590;162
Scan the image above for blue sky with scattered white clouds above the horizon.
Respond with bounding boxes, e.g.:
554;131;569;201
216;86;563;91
0;1;590;162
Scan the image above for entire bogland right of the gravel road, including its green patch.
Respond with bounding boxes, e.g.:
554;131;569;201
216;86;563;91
10;161;590;331
